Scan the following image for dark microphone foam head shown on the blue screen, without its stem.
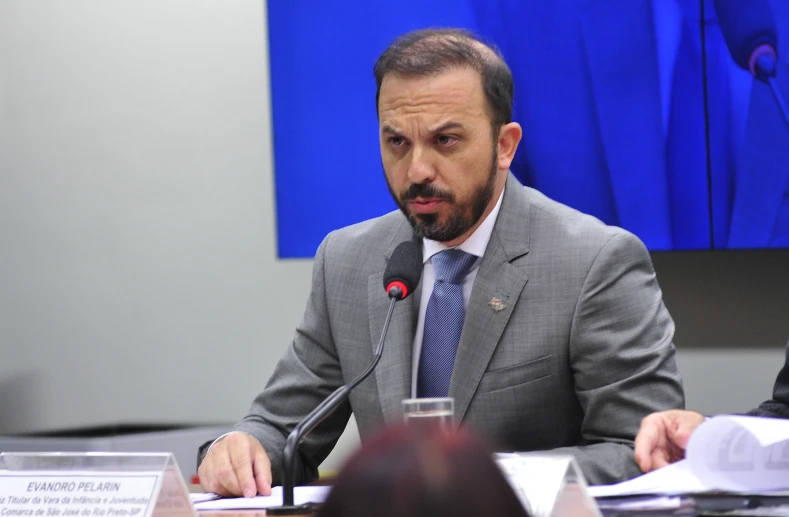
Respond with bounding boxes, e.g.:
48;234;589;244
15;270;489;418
714;0;778;71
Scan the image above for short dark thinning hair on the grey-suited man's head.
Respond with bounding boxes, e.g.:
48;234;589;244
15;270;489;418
373;28;514;133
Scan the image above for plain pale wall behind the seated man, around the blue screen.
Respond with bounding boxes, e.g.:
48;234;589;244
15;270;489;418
0;0;783;472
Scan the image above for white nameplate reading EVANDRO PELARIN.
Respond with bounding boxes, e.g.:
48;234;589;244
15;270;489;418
0;470;161;517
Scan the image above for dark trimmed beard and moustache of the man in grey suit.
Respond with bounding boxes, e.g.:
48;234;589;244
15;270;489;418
387;152;498;242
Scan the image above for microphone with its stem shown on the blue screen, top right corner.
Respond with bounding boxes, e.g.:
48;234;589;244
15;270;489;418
714;0;789;127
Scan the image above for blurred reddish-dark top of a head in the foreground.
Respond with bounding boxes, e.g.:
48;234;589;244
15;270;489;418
318;426;528;517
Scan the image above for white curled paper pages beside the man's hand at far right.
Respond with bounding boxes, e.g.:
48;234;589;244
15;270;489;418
589;416;789;497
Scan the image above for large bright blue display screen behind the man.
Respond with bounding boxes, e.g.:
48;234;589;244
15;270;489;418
268;0;789;258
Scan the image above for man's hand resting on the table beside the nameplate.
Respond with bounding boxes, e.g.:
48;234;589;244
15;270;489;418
197;432;271;497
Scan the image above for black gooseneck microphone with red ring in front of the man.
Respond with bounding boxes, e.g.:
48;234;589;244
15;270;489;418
266;240;423;515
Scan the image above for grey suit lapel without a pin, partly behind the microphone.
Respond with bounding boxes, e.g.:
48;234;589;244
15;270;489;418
367;219;419;422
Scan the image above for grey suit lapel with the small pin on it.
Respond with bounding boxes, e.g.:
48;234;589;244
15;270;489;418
449;174;529;422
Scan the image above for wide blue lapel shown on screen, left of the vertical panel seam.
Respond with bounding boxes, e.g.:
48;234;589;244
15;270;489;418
581;0;671;248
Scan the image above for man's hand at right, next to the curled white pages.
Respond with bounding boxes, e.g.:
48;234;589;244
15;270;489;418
635;409;704;472
